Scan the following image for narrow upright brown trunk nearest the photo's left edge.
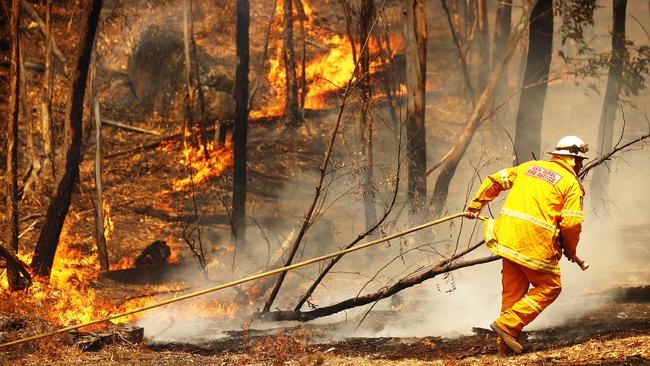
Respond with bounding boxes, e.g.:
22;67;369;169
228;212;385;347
5;0;23;291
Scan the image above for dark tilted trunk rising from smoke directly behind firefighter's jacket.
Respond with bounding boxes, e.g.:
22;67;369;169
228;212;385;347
515;0;553;164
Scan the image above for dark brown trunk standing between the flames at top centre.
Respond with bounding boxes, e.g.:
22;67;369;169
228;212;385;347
282;0;300;127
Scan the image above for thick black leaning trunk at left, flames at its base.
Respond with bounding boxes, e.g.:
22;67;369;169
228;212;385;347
31;0;102;276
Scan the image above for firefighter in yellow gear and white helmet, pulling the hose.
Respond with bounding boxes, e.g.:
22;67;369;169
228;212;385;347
466;136;588;354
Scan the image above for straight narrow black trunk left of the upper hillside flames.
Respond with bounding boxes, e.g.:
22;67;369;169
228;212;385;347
232;0;250;244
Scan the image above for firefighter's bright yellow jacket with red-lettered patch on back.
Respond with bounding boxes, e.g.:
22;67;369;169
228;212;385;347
469;157;584;274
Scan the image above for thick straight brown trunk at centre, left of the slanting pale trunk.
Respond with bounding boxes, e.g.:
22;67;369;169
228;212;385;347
404;0;427;218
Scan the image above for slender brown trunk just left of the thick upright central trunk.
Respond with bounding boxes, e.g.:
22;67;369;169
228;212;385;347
360;0;377;235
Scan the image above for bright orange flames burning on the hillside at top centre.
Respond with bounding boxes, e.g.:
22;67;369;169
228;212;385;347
250;0;404;118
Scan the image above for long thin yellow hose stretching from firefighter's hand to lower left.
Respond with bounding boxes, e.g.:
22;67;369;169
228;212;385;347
0;212;465;348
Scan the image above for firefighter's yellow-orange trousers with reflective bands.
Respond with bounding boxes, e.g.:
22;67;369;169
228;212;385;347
495;258;562;338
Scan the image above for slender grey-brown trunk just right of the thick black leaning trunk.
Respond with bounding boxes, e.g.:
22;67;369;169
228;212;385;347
93;98;109;271
